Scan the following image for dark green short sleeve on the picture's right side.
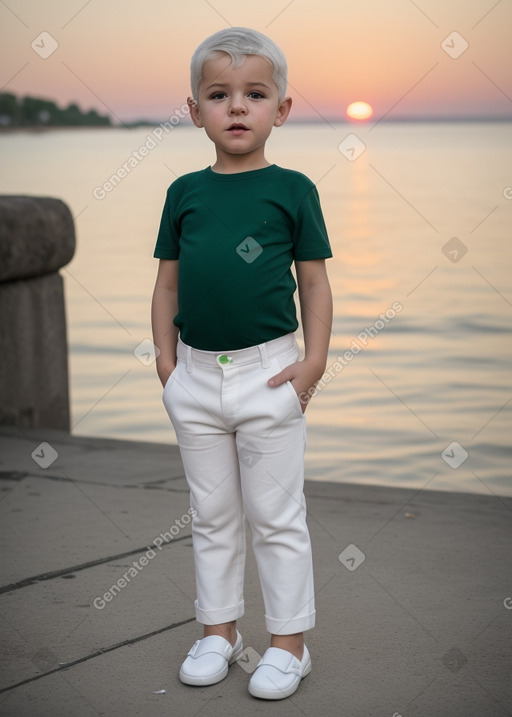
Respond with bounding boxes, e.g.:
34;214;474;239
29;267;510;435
292;182;332;261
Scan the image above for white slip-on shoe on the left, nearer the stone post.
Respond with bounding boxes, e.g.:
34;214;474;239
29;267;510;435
180;630;244;685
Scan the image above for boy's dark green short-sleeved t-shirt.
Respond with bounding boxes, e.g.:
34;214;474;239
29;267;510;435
154;164;332;351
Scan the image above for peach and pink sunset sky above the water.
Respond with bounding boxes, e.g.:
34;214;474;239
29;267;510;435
0;0;512;122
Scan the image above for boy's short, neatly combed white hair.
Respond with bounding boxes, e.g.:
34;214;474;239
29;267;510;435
190;27;288;102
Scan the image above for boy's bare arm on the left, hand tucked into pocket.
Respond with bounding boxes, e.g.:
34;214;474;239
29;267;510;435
151;259;178;386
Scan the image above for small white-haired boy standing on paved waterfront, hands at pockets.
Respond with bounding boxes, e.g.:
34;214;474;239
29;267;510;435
152;28;332;699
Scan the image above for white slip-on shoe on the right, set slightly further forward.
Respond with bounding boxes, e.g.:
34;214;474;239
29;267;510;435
249;645;311;700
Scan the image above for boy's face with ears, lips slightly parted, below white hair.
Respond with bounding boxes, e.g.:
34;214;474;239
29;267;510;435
191;54;291;162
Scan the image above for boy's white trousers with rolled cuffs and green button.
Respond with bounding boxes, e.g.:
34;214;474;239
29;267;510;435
163;334;315;635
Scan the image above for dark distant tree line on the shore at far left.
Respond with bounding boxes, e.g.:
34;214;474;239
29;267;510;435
0;92;112;127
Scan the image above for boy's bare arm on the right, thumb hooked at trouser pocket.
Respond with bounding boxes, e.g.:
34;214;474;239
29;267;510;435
269;259;332;411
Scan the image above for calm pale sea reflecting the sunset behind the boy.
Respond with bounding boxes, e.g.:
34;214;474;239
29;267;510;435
0;120;512;500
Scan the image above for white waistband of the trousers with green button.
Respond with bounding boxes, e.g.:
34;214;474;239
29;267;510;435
176;334;297;373
